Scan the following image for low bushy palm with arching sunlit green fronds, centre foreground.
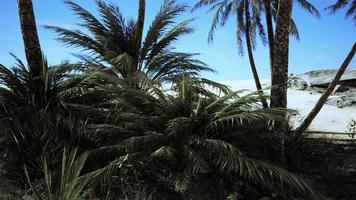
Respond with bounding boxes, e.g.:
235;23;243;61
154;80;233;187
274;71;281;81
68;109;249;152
89;77;320;199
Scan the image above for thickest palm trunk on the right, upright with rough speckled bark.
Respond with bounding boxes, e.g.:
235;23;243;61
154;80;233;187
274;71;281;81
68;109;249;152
270;0;292;108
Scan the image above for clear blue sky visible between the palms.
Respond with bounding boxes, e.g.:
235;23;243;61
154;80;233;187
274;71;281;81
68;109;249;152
0;0;356;80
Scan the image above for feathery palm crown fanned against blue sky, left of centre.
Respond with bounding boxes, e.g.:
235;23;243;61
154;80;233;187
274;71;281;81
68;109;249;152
47;0;212;89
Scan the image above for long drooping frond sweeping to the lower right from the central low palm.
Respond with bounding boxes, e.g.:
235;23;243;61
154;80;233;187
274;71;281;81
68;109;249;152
202;139;323;199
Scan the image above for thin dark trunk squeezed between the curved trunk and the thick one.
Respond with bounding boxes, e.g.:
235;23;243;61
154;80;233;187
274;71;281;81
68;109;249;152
264;0;274;68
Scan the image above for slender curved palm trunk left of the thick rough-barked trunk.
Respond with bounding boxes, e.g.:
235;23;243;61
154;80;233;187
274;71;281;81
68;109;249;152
245;0;268;108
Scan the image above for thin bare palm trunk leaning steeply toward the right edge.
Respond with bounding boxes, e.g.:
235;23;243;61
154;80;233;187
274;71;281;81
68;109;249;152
296;42;356;137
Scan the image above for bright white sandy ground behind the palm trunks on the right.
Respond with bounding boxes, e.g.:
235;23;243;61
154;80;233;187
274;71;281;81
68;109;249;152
222;79;356;133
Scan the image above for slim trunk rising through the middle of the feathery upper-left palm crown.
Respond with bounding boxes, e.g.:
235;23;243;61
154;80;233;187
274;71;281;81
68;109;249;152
130;0;146;88
